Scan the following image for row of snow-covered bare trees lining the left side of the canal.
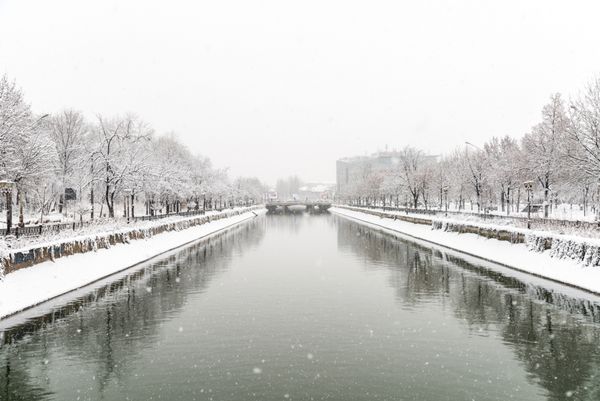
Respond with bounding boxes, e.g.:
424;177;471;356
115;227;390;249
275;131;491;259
0;72;266;228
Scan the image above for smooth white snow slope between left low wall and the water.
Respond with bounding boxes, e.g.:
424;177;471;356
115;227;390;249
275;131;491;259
0;211;262;318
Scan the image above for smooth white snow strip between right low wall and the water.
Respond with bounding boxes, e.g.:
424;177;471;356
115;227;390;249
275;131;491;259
330;207;600;294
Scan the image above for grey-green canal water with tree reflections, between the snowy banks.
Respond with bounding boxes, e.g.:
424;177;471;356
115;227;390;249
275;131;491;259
0;215;600;401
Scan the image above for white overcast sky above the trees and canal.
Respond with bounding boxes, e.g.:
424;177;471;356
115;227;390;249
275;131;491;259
0;0;600;183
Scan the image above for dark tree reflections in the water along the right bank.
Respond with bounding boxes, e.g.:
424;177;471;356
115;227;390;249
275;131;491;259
338;216;600;400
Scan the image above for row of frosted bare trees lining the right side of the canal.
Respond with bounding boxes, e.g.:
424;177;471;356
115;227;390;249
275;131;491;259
338;78;600;217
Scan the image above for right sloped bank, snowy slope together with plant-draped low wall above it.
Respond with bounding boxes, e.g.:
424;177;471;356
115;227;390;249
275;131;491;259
331;206;600;294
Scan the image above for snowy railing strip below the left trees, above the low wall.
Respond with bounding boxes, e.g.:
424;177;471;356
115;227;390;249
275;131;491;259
0;208;234;238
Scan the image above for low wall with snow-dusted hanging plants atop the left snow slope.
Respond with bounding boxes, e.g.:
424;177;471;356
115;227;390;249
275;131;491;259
0;206;262;278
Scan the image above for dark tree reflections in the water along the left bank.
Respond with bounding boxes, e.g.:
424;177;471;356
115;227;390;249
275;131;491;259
0;219;265;400
